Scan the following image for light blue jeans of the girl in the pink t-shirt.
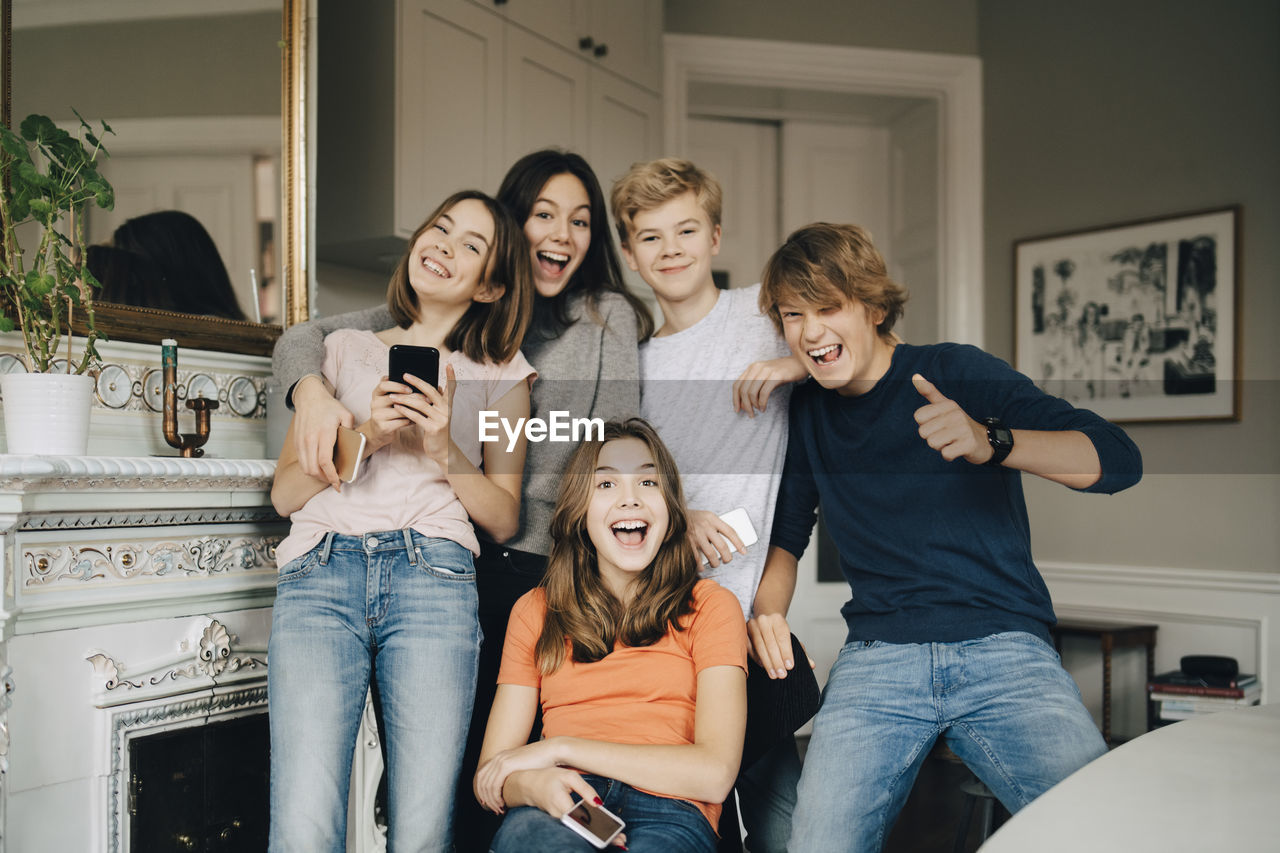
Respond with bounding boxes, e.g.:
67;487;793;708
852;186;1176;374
268;530;480;853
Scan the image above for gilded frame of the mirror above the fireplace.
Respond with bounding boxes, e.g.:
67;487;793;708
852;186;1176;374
0;0;310;356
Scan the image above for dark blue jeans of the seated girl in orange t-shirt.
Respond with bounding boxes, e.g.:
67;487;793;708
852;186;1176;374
489;776;716;853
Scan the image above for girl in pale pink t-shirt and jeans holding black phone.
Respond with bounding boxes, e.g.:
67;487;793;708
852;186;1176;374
269;191;534;853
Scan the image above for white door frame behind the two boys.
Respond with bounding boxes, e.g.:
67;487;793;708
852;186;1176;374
663;35;984;346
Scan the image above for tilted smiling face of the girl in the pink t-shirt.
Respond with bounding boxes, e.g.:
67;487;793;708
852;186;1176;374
408;199;502;305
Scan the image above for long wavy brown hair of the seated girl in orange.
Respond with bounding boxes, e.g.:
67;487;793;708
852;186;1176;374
535;418;698;675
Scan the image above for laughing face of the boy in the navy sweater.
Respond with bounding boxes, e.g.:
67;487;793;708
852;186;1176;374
778;290;893;396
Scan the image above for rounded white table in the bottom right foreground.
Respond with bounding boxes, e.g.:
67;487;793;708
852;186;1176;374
982;704;1280;853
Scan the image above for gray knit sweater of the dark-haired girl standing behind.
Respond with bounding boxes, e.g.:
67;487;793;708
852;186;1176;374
271;293;640;556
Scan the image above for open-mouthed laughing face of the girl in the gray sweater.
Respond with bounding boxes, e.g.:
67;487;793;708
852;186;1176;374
525;172;591;298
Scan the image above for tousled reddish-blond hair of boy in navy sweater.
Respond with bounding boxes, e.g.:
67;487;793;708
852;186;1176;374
759;222;909;338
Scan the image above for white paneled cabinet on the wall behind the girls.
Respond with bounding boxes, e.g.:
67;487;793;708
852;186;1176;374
316;0;662;266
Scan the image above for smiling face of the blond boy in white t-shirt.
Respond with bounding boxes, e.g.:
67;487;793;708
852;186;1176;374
622;191;721;314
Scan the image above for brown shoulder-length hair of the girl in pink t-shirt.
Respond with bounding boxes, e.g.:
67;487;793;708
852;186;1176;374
387;190;534;364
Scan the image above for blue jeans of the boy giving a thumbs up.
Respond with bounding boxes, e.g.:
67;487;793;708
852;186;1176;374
788;631;1106;853
